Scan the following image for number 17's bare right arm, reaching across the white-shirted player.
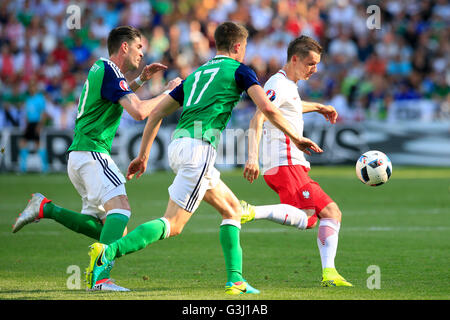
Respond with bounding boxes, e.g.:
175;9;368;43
247;85;323;155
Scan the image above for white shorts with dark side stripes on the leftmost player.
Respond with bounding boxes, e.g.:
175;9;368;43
67;151;126;220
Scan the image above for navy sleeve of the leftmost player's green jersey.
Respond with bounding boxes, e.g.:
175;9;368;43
101;63;133;103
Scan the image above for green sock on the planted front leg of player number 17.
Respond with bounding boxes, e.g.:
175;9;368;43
219;224;243;282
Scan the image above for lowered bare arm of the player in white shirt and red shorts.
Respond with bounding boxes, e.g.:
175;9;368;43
244;109;266;183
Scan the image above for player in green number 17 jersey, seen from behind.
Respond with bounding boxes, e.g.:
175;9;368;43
86;22;322;294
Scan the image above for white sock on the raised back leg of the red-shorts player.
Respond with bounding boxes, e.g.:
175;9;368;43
254;204;308;230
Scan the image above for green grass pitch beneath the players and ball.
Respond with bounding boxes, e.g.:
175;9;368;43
0;167;450;300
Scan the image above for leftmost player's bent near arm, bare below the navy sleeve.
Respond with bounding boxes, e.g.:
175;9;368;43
119;78;181;121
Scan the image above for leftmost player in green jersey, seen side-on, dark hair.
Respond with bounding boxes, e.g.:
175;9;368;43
13;26;181;290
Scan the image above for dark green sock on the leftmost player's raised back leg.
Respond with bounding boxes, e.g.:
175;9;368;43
43;202;103;240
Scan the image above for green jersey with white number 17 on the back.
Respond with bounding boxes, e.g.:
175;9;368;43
170;56;259;148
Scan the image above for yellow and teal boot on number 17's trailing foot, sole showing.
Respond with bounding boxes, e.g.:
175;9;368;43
86;242;114;289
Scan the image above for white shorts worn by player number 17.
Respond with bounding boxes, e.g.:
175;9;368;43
169;138;220;213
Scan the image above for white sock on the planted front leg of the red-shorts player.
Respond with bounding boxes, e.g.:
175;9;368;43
317;219;341;269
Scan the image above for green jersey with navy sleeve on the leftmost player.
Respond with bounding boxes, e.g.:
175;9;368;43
68;58;132;154
